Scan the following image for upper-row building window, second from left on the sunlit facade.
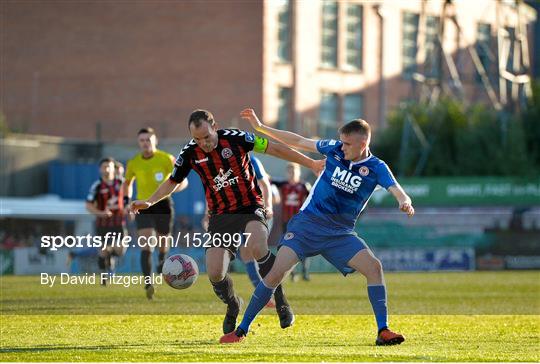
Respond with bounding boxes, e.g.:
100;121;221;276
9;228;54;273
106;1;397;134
321;0;338;68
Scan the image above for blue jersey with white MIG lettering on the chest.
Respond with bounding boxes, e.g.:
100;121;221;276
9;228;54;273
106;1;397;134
298;139;397;232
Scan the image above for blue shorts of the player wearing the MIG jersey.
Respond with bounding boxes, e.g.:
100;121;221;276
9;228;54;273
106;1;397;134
279;214;367;276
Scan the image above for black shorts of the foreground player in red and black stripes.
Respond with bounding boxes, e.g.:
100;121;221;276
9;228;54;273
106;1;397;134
207;206;268;260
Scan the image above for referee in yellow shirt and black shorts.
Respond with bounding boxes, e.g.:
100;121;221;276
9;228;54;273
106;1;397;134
124;127;187;299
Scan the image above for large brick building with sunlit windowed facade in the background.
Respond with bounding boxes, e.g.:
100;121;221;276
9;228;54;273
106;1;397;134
0;0;535;141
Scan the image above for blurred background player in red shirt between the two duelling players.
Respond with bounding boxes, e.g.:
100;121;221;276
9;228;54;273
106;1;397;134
272;163;311;282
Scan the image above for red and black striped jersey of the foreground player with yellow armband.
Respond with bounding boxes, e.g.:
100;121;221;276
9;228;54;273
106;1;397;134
170;129;268;215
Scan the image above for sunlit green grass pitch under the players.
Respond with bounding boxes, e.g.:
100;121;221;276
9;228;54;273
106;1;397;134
0;271;540;362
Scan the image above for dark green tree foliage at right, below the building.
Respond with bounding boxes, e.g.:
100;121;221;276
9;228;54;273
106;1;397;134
372;89;540;176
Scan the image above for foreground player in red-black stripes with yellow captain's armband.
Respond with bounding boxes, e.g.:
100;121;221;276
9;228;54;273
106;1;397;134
131;110;324;333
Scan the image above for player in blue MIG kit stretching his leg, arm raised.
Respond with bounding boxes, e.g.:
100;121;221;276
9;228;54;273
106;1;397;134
220;109;414;345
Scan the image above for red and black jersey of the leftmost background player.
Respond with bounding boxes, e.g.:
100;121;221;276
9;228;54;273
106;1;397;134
86;178;125;227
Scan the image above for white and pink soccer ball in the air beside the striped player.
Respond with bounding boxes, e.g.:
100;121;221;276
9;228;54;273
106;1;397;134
162;254;199;289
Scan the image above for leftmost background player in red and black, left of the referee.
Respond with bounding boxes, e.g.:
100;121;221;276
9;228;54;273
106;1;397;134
86;158;127;285
